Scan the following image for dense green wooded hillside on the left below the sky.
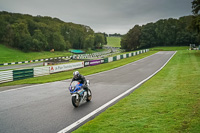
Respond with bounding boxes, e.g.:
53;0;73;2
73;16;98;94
0;11;106;51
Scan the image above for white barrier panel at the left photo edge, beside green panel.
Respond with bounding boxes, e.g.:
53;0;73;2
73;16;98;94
0;70;13;83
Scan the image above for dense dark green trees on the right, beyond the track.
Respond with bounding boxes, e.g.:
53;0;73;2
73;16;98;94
121;16;200;50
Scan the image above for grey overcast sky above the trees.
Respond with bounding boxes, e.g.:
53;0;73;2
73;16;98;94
0;0;193;34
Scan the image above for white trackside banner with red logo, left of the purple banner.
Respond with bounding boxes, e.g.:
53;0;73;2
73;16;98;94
49;62;84;73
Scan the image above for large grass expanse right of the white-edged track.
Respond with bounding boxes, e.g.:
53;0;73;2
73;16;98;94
74;50;200;133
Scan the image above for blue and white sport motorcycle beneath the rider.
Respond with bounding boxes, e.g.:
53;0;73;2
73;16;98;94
69;80;92;107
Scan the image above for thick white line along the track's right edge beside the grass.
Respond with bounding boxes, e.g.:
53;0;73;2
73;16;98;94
58;51;177;133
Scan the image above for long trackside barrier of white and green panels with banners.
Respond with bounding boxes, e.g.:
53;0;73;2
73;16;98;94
0;49;149;83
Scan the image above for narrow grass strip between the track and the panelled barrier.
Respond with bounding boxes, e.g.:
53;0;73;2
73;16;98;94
0;51;157;87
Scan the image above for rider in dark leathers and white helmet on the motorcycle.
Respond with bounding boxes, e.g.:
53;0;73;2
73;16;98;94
71;71;88;94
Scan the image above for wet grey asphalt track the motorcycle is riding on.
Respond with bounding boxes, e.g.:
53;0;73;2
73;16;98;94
0;51;175;133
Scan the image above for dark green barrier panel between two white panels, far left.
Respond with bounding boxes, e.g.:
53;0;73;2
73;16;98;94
13;69;33;81
